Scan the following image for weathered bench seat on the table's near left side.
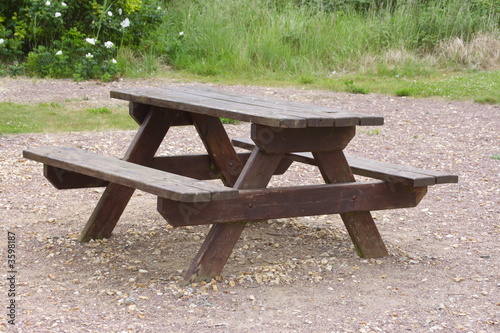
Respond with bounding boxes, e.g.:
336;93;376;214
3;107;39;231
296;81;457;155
23;147;238;202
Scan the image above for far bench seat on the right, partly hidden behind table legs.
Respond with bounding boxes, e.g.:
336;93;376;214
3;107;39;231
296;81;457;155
232;138;458;187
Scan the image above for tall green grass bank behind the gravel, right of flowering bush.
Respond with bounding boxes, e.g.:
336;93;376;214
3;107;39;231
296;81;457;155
152;0;500;78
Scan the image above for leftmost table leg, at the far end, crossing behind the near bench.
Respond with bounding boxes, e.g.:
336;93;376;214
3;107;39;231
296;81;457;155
79;107;178;242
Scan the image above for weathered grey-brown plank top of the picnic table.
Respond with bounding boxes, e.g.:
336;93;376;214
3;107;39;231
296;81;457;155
111;86;384;128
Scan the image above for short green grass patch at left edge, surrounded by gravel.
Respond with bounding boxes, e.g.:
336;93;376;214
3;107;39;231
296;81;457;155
0;102;137;134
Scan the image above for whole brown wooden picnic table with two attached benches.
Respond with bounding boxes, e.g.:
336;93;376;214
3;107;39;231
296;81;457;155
24;87;458;281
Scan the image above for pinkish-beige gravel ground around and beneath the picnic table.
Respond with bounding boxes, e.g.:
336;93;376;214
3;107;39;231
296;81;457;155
0;79;500;332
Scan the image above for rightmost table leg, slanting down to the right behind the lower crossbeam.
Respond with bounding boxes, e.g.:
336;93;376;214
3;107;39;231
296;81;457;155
313;150;388;258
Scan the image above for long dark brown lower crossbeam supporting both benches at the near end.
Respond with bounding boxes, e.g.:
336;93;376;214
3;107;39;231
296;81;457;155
158;181;427;227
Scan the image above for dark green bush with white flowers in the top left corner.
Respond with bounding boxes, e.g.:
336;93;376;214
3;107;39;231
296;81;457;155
0;0;163;80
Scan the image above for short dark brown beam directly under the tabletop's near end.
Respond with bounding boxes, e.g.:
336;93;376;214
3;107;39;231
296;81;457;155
251;124;356;153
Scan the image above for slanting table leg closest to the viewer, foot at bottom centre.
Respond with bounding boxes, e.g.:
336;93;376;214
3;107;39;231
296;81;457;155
185;148;284;282
